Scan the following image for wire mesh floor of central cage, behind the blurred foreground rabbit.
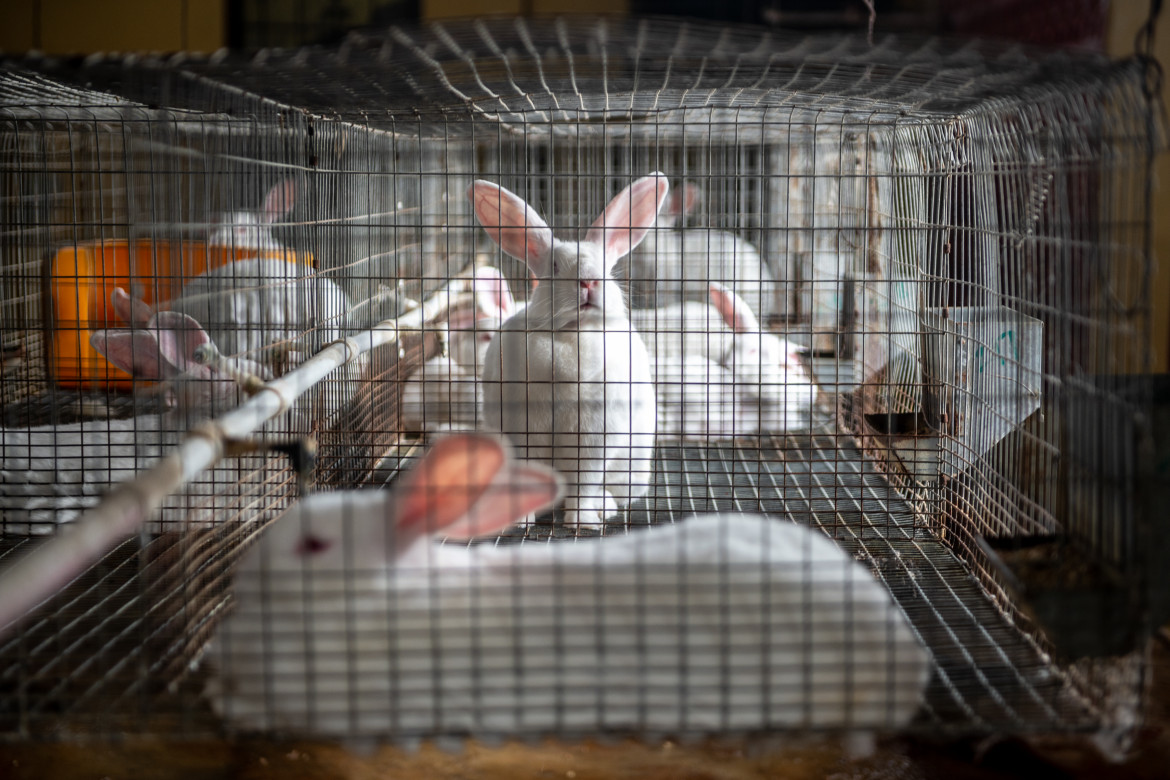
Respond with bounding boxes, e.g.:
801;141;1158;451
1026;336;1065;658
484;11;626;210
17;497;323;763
379;421;1096;733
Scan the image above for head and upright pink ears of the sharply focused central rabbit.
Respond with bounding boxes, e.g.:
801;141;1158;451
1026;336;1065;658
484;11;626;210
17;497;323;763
468;173;669;330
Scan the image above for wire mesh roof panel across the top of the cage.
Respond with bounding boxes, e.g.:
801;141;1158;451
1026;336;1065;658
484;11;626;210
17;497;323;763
50;18;1127;130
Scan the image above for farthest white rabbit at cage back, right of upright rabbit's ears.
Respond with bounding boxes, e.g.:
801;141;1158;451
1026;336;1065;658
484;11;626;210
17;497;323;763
614;182;776;318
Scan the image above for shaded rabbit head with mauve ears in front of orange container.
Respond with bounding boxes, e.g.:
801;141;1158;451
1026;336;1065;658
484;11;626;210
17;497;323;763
89;288;269;407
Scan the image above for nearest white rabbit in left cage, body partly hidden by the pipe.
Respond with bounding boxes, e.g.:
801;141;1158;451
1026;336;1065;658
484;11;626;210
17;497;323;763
0;289;267;534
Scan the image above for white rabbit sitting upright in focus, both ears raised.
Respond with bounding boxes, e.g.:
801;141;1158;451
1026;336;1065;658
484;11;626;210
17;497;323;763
468;173;668;527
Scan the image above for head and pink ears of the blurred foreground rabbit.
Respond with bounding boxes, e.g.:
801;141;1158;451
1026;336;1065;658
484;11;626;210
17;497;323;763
253;434;562;573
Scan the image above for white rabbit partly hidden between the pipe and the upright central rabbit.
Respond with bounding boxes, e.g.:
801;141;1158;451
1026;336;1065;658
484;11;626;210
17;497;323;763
402;267;522;430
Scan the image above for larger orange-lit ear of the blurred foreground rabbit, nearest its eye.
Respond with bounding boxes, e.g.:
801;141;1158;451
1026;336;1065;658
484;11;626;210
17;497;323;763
390;434;508;548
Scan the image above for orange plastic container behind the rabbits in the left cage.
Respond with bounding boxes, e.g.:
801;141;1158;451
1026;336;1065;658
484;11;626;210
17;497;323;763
48;240;312;391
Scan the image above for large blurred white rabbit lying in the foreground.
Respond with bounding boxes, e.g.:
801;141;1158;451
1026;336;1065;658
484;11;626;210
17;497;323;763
206;434;931;740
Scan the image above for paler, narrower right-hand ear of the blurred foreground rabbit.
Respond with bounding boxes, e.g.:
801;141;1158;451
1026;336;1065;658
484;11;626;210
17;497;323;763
443;463;563;539
